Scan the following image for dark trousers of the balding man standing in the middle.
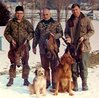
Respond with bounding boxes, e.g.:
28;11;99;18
40;54;57;88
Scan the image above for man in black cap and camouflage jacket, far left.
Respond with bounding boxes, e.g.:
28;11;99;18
4;6;34;86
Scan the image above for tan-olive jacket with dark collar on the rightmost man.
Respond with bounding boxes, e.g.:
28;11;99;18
65;12;94;52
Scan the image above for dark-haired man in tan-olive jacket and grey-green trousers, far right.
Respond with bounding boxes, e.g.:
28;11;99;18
65;4;94;91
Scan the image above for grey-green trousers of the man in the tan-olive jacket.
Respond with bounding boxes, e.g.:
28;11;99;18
71;52;89;79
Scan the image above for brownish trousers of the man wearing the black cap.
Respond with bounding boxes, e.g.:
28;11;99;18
8;47;30;79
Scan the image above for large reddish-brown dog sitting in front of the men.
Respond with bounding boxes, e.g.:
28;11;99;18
52;52;74;96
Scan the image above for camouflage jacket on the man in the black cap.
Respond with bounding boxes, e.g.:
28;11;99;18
4;18;34;46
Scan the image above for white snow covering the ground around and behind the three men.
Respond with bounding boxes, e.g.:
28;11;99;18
0;20;99;98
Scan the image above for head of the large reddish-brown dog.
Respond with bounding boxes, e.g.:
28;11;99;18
61;53;74;65
